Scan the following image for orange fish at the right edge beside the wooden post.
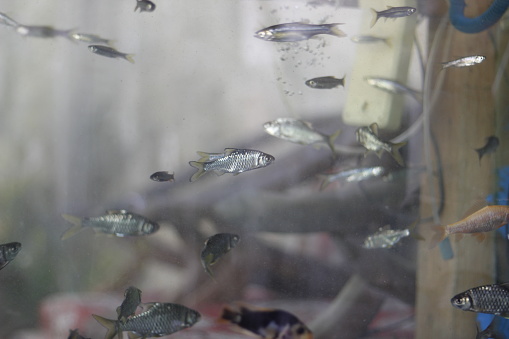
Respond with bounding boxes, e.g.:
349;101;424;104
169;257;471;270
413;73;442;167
430;205;509;248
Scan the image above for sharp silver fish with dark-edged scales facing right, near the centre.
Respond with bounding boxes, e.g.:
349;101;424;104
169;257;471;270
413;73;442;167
189;148;274;182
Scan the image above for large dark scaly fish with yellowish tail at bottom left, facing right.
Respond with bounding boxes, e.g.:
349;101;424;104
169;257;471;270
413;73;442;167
92;303;201;339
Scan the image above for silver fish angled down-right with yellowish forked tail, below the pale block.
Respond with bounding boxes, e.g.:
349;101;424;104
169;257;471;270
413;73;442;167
355;123;406;166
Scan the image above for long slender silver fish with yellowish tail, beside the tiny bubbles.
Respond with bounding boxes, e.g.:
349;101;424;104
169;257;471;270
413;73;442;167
254;22;346;42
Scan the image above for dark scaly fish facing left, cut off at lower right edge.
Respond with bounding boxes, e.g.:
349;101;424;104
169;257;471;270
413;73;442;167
451;283;509;317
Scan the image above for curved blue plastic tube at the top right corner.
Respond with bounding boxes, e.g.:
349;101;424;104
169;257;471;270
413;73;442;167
449;0;509;33
